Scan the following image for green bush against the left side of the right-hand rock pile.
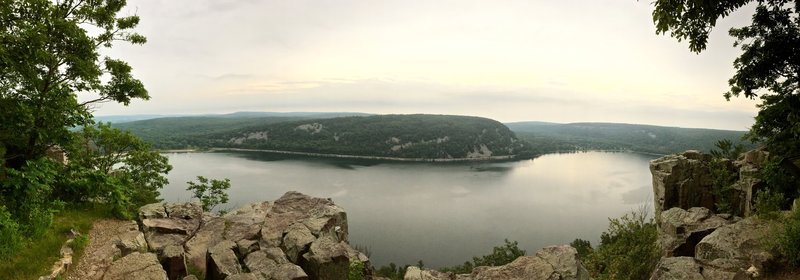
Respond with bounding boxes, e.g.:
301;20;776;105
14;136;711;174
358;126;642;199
583;208;661;279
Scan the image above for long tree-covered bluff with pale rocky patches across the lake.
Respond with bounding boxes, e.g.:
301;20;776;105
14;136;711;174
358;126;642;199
209;115;525;158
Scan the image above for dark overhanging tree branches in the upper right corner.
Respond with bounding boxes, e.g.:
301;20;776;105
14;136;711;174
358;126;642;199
653;0;800;160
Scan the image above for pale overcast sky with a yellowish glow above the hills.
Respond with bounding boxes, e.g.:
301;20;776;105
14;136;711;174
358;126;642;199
90;0;757;130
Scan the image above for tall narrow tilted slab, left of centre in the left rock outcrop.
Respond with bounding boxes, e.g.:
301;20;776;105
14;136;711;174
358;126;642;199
184;217;225;273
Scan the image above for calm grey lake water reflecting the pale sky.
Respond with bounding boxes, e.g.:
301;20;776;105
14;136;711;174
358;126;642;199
161;152;654;267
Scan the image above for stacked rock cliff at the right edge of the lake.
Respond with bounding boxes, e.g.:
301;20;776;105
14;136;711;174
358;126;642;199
650;150;772;280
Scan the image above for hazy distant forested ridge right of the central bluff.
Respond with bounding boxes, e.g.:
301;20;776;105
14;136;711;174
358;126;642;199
506;122;754;154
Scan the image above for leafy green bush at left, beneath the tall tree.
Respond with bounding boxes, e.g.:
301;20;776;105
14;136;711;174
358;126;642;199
58;123;172;217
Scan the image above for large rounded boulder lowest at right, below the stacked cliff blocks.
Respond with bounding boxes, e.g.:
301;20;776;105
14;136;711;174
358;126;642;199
695;217;770;271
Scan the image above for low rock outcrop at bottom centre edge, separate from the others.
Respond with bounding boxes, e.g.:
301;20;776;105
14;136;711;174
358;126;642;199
403;245;591;280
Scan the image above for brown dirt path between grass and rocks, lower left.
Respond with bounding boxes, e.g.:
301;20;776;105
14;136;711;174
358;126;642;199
67;220;137;280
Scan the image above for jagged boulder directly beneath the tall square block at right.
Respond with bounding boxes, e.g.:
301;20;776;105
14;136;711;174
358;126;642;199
658;207;739;257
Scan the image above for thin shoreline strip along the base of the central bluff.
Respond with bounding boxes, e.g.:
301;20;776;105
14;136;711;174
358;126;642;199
159;148;517;162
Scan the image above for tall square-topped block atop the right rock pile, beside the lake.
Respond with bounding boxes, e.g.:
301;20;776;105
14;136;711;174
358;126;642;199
650;151;715;219
